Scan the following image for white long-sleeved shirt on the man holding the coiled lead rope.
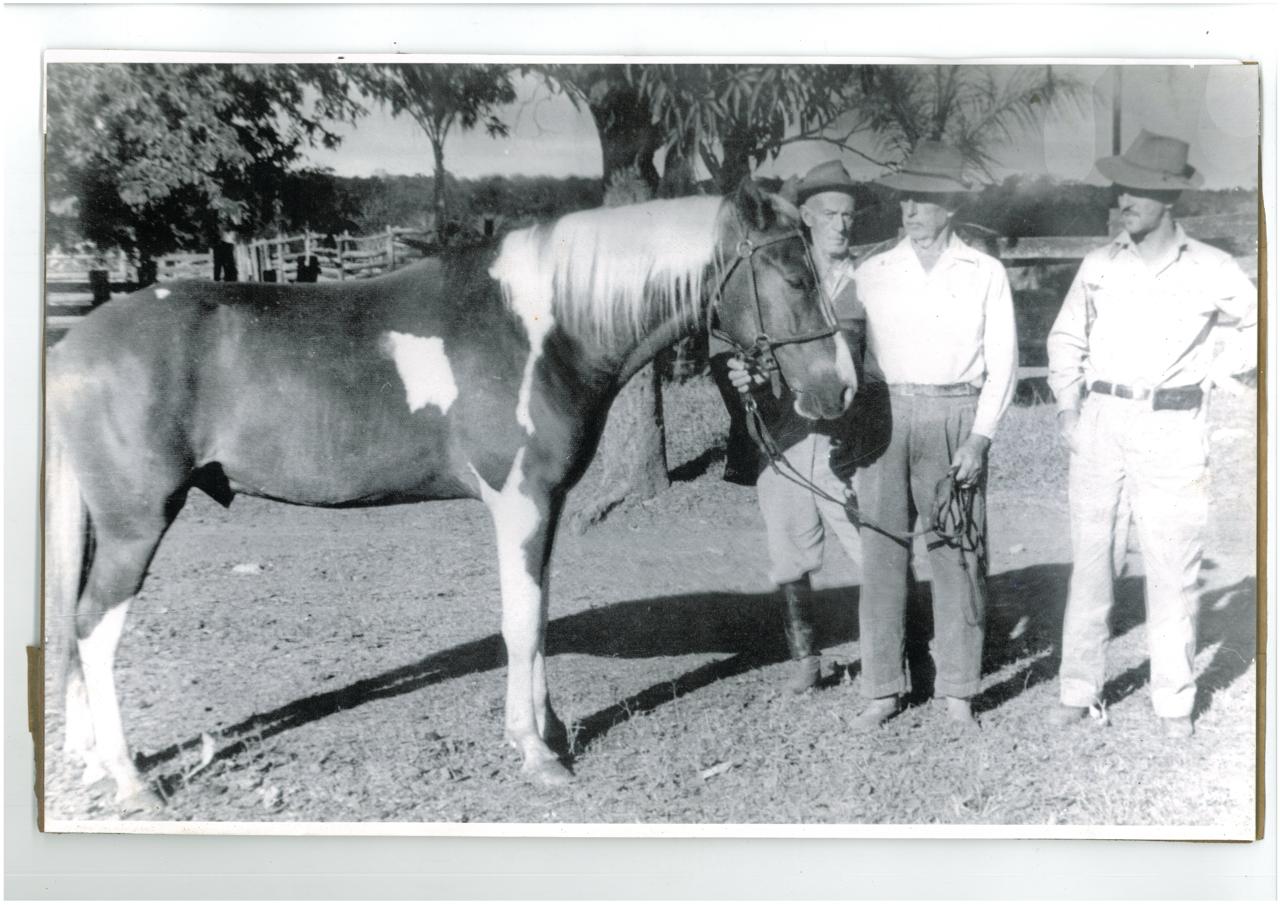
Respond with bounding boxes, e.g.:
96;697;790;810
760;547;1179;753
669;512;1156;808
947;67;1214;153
856;234;1018;436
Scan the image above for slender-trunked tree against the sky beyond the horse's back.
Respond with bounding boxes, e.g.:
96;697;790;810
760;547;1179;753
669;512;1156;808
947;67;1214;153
357;63;516;234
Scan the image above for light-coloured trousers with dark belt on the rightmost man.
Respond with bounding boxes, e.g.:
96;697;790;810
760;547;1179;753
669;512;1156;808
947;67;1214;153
1059;394;1208;718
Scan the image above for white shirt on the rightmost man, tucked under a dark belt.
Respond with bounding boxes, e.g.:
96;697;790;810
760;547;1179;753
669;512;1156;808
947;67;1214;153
1048;225;1258;410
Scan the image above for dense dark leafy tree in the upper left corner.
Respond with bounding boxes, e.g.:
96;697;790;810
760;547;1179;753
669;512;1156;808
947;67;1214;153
46;63;362;260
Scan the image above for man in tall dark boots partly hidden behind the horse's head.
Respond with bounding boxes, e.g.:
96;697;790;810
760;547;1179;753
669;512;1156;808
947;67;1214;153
712;160;865;694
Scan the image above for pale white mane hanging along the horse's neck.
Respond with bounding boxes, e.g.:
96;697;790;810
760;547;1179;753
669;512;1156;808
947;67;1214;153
490;196;721;342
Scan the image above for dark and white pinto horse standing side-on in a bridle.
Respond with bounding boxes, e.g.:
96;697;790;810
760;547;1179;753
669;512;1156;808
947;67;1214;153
45;182;856;812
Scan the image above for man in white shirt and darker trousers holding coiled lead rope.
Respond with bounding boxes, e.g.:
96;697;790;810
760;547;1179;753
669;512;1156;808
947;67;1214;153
855;141;1018;730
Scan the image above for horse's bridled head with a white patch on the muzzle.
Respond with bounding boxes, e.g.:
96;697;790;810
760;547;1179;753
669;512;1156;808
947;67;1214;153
717;179;858;419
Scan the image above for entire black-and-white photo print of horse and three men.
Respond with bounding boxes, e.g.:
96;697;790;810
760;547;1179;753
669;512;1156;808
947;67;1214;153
40;51;1261;840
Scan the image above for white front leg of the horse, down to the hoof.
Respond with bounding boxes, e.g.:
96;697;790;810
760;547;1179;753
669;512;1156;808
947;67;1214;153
481;449;570;785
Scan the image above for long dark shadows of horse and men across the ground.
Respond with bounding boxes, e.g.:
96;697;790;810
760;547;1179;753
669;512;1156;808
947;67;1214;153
138;563;1257;794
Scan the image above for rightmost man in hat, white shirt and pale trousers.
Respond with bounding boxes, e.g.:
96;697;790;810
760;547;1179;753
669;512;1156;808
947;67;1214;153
1048;131;1257;739
